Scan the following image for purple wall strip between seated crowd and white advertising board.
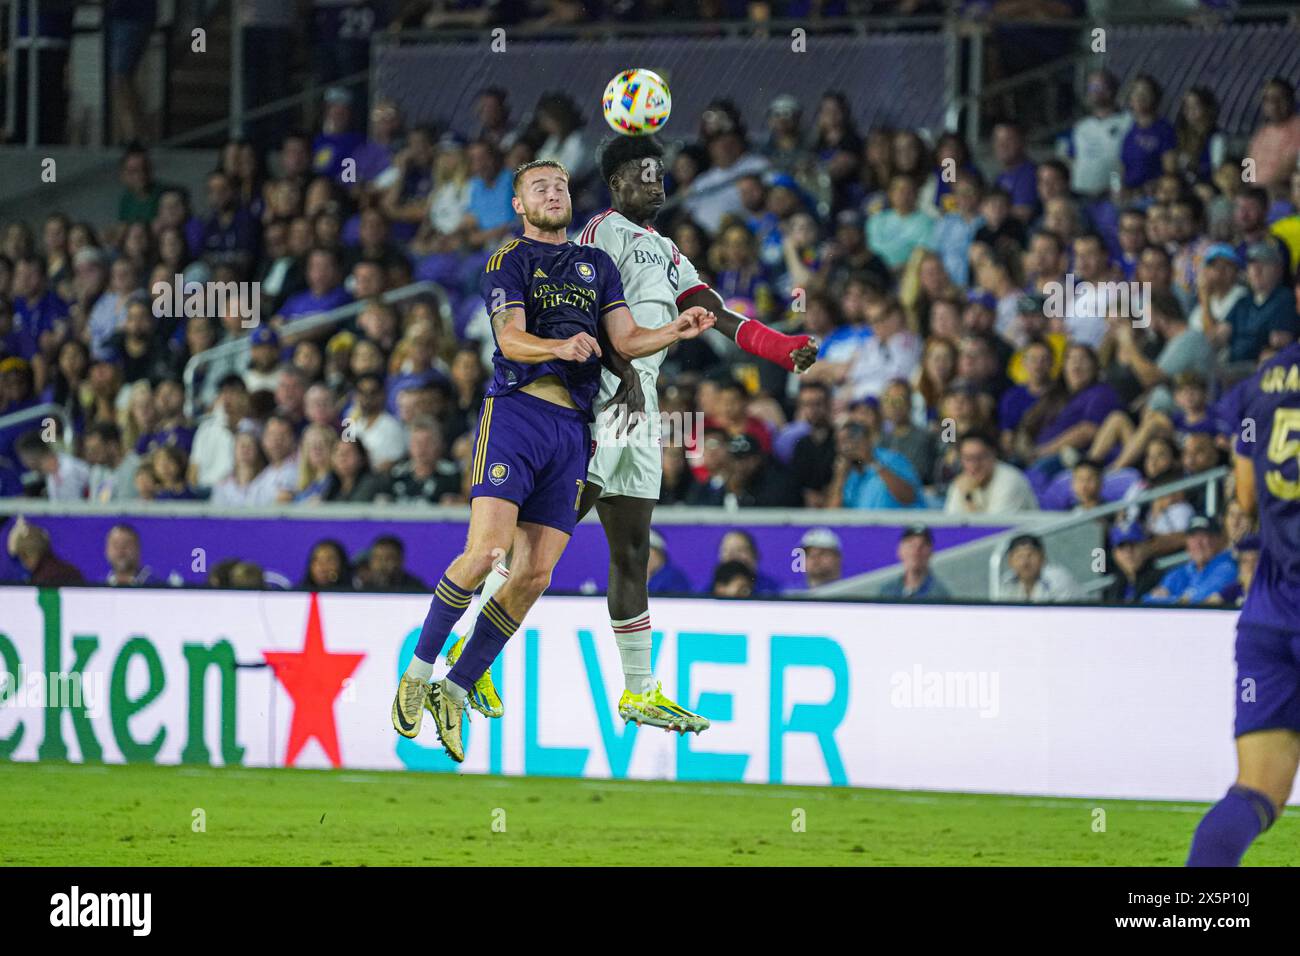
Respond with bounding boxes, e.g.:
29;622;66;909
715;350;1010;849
0;512;1013;594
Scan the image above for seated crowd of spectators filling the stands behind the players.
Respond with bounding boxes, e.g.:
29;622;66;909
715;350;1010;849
0;52;1300;602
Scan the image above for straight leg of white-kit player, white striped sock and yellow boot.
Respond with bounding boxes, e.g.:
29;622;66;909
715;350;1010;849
595;489;709;734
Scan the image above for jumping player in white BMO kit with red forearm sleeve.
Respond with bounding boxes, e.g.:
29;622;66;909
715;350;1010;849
447;137;816;734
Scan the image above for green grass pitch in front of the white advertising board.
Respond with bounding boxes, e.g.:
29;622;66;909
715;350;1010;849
0;763;1300;866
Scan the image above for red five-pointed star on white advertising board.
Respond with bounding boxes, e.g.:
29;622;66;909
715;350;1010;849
261;593;365;767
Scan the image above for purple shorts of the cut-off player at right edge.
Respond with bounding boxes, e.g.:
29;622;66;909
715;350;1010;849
1234;624;1300;736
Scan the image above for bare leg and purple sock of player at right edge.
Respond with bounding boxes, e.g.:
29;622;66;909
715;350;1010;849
1187;730;1300;866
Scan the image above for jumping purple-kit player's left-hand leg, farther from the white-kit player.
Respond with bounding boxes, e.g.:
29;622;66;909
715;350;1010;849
393;497;519;743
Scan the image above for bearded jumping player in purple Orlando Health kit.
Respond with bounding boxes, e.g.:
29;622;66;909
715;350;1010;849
393;160;716;762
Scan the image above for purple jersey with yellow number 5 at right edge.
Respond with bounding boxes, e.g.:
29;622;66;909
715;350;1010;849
1236;345;1300;631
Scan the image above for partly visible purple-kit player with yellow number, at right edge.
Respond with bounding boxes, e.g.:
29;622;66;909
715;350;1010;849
1187;345;1300;866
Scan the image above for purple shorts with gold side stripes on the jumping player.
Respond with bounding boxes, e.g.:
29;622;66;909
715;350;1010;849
469;392;592;535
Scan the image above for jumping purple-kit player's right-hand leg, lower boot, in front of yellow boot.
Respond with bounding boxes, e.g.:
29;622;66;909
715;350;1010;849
428;515;569;762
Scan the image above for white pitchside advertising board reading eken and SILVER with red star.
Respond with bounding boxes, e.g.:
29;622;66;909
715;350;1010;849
0;588;1235;800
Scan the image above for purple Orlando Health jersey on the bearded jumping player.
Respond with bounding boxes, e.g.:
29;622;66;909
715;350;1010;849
478;237;627;421
